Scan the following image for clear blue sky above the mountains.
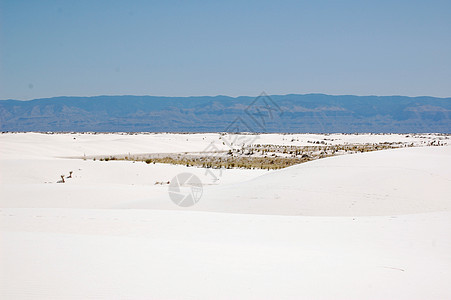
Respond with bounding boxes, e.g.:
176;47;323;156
0;0;451;99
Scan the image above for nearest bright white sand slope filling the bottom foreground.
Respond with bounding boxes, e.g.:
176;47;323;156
0;209;451;299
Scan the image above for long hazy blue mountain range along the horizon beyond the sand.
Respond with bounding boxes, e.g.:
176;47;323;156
0;94;451;133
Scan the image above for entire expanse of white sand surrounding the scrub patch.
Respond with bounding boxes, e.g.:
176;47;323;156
0;134;451;299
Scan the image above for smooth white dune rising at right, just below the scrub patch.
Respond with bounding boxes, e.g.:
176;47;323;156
191;147;451;216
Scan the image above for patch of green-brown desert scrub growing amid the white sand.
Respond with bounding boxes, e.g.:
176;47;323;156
92;140;441;170
